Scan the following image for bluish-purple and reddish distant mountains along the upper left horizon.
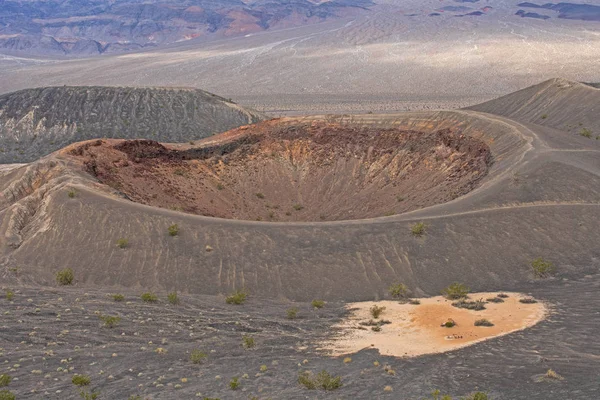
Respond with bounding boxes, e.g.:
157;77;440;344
0;0;373;56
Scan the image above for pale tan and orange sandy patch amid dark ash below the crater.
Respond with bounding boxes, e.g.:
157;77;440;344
323;293;547;357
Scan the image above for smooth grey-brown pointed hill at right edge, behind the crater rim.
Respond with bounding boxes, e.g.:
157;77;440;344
469;79;600;138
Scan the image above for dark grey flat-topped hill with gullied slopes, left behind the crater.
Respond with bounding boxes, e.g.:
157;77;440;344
0;86;264;163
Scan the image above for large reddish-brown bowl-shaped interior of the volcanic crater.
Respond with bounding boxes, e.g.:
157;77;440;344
67;120;492;222
